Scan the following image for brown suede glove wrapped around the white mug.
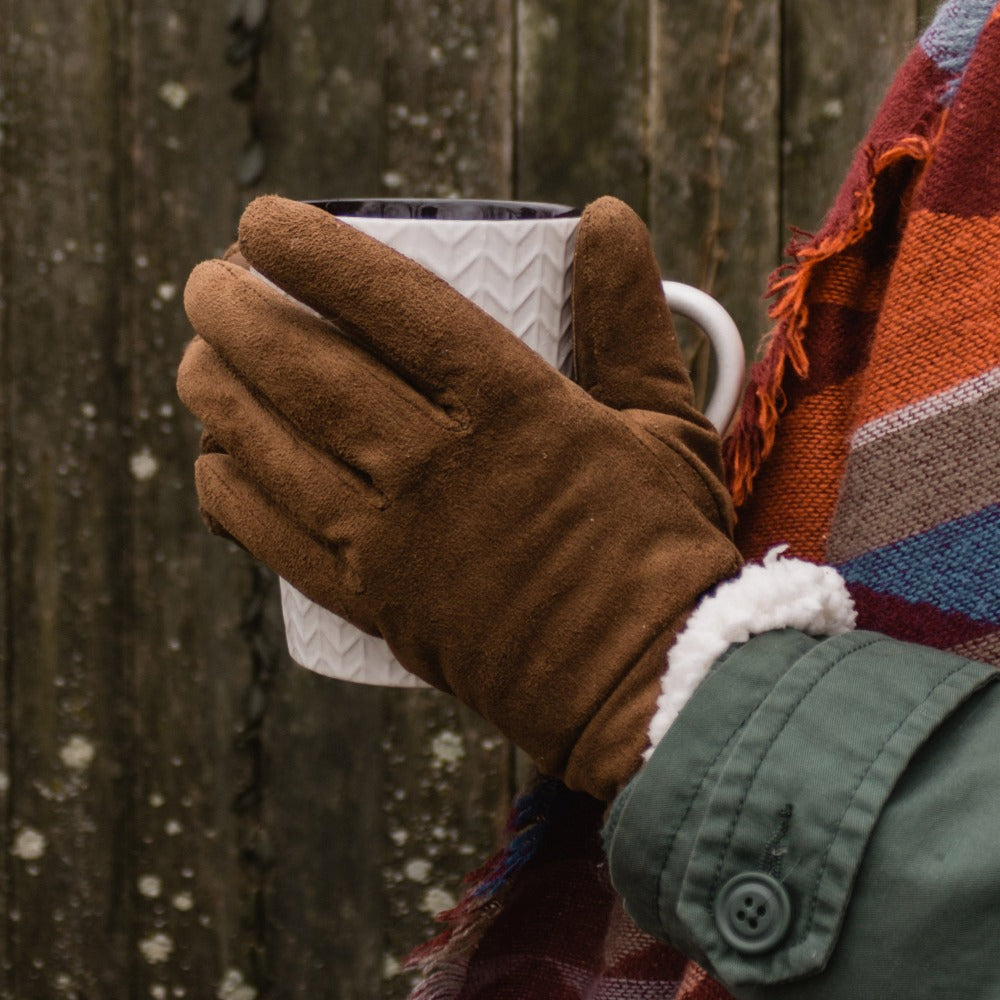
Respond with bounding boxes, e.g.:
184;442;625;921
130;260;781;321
178;197;740;800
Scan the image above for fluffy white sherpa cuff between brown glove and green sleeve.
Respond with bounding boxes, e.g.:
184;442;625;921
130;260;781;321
643;545;857;760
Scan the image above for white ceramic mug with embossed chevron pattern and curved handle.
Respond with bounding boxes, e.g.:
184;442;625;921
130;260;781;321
281;199;744;687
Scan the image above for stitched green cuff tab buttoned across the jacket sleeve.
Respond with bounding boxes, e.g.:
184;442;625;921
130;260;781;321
657;632;995;985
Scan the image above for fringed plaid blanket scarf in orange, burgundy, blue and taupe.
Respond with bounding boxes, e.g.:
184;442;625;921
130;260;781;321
413;0;1000;1000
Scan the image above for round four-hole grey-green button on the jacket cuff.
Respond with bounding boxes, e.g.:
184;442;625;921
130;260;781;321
715;872;792;955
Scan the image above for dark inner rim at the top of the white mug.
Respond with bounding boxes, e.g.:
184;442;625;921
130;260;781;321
306;198;580;222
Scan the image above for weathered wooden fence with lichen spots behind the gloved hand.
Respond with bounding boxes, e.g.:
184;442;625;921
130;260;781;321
0;0;932;1000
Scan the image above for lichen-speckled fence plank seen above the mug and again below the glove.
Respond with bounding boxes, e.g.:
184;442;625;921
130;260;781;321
381;0;514;997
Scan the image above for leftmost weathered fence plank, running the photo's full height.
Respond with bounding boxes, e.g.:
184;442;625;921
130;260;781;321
0;0;134;996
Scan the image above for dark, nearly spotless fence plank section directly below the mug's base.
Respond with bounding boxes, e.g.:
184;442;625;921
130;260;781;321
262;636;387;1000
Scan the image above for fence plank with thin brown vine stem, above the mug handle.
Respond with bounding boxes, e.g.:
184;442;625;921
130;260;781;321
650;0;781;368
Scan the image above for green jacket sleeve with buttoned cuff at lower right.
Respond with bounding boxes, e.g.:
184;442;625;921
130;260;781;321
605;630;1000;1000
